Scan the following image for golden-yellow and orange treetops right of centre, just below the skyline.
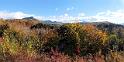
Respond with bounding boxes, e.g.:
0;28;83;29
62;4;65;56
65;23;107;44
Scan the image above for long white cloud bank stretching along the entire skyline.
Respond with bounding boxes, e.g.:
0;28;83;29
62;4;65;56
0;10;124;23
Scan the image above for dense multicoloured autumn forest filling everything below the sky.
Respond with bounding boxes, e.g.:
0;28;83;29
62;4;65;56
0;18;124;62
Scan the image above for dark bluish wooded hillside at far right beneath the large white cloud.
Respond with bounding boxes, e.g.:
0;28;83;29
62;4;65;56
92;22;124;38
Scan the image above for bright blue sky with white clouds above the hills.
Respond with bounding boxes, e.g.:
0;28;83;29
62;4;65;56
0;0;124;23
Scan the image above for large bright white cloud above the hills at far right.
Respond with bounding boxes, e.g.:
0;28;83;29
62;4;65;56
93;10;124;23
